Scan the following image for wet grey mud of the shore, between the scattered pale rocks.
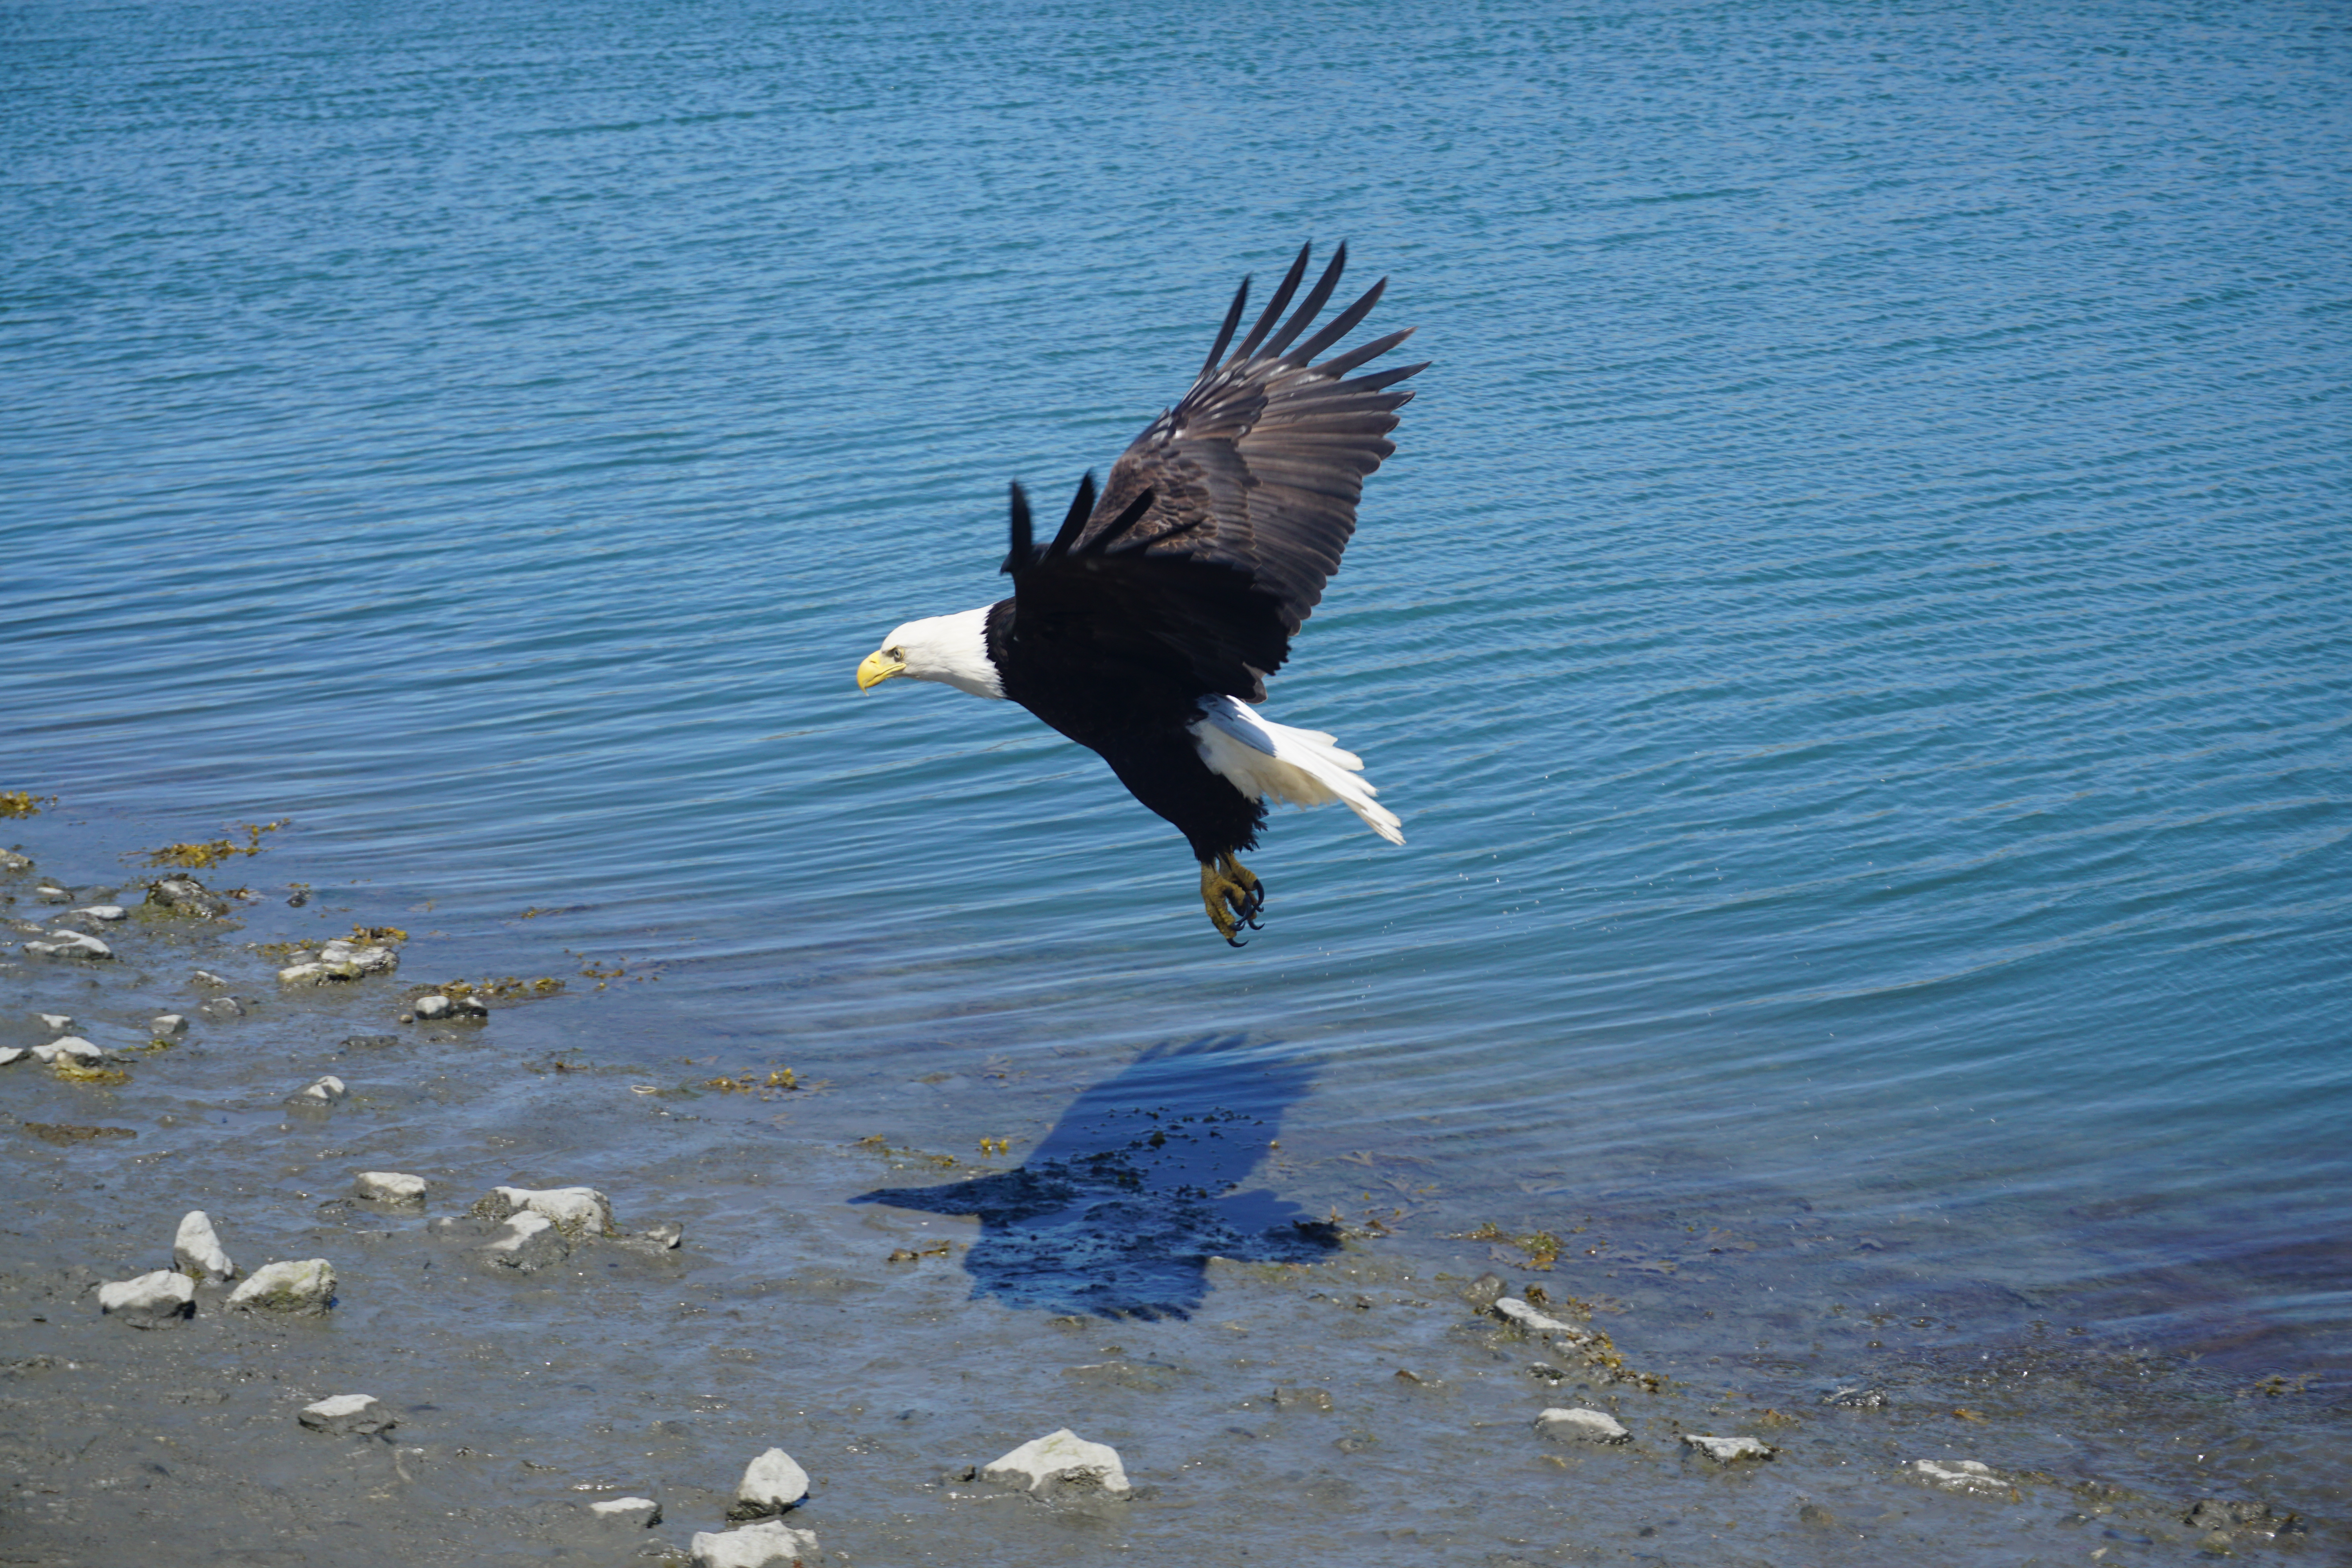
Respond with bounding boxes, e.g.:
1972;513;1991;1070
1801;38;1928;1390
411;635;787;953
0;841;2352;1566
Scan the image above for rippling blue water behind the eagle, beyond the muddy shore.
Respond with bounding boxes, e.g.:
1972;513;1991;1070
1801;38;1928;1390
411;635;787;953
0;0;2352;1368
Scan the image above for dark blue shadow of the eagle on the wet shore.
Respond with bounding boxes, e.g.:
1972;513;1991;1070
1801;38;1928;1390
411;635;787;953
851;1039;1338;1319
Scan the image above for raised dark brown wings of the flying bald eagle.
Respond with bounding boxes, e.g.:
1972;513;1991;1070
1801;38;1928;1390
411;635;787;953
1004;245;1423;701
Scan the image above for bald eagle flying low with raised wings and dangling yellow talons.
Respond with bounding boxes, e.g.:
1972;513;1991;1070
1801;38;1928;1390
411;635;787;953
858;245;1425;947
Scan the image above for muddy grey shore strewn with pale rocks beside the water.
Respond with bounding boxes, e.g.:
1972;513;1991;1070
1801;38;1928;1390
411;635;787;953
0;827;2352;1568
